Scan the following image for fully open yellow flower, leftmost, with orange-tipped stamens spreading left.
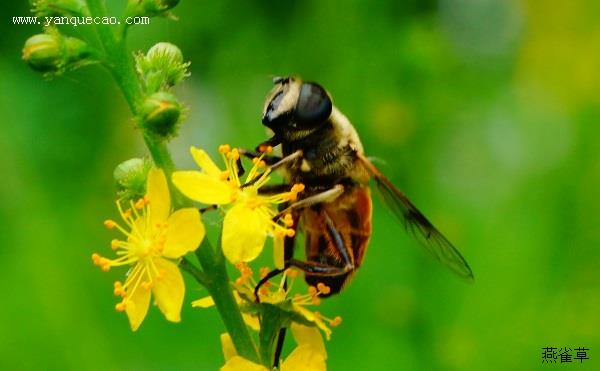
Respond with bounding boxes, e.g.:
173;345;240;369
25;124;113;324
92;168;205;331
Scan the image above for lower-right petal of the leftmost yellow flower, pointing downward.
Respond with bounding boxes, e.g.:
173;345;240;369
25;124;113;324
152;258;185;322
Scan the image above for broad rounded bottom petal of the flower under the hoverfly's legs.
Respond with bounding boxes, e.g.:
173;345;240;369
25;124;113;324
223;203;267;264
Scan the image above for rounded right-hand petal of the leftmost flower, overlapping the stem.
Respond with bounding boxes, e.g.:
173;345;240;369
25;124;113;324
162;208;206;258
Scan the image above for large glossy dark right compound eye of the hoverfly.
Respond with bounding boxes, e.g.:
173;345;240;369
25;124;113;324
295;83;332;124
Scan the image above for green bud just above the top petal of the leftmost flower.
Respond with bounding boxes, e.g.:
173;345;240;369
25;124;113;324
113;158;152;202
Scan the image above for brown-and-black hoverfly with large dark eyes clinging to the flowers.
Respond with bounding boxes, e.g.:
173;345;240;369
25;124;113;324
245;77;473;296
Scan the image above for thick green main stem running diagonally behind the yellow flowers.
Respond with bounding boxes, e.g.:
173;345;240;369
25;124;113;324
87;0;259;362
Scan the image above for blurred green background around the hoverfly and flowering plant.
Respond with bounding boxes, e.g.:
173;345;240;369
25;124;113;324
0;0;600;370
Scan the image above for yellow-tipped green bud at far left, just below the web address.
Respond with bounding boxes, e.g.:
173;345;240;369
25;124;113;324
23;27;95;74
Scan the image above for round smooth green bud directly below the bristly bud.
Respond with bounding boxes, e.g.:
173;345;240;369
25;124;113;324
140;91;182;139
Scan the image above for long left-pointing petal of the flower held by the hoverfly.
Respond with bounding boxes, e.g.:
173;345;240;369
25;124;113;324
173;171;235;205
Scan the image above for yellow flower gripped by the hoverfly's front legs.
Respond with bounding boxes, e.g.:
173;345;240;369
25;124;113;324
173;145;304;264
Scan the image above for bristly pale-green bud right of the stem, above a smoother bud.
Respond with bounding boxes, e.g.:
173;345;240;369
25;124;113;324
135;42;190;93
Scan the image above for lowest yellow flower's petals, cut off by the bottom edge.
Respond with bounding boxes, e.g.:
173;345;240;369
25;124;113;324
221;324;327;371
